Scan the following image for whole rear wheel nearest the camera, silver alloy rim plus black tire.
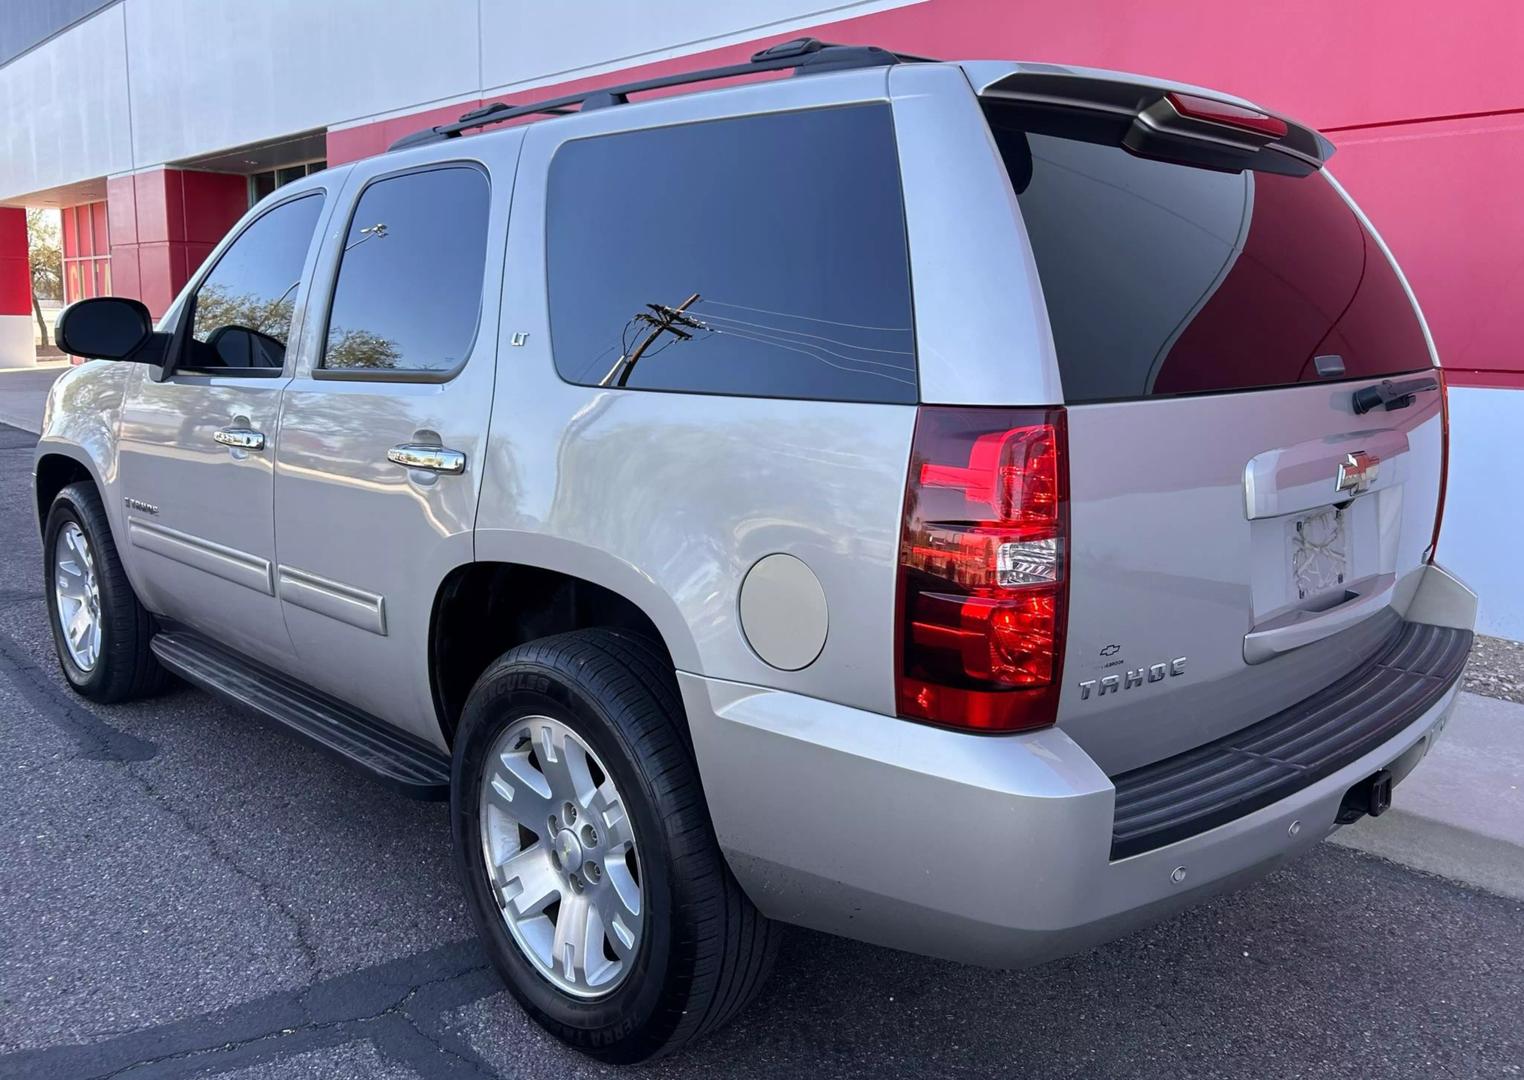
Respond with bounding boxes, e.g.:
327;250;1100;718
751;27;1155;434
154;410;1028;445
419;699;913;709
451;629;777;1063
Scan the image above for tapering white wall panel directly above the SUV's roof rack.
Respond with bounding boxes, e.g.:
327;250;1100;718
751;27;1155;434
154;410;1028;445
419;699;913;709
482;0;919;93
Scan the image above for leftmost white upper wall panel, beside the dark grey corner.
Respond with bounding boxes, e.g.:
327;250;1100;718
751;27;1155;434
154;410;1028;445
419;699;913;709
0;5;133;200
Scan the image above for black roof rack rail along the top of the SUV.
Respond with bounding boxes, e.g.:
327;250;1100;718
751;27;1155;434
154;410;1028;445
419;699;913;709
387;38;928;151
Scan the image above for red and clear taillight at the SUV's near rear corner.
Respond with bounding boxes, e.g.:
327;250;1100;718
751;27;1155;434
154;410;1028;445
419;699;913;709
898;407;1068;731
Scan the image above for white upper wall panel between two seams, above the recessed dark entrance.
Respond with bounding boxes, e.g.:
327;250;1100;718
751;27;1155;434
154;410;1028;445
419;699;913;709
125;0;481;166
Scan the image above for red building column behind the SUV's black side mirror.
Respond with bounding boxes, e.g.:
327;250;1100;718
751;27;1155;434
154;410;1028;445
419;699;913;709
107;168;248;318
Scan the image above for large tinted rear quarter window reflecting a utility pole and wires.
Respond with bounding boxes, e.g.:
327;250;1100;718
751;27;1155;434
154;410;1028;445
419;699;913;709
546;105;916;402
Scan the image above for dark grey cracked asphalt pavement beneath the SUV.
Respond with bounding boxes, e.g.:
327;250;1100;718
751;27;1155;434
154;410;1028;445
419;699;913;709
0;414;1524;1080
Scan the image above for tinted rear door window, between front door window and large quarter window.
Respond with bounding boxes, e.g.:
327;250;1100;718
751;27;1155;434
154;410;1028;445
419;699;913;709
323;166;488;372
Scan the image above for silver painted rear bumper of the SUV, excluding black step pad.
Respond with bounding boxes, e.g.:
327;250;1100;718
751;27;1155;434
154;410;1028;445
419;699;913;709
680;563;1475;967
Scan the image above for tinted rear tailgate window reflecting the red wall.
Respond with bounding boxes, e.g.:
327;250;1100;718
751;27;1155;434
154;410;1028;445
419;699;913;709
989;107;1431;402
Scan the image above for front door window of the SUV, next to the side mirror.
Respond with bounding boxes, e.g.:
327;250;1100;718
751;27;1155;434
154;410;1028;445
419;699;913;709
180;192;323;376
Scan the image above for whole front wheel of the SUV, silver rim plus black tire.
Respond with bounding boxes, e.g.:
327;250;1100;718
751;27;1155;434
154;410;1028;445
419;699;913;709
43;483;168;702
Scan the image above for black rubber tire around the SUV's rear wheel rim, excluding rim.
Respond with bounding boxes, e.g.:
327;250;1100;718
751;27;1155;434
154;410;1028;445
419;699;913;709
450;629;780;1063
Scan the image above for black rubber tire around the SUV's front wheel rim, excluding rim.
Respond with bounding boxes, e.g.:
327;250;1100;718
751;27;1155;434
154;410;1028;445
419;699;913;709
43;481;169;704
